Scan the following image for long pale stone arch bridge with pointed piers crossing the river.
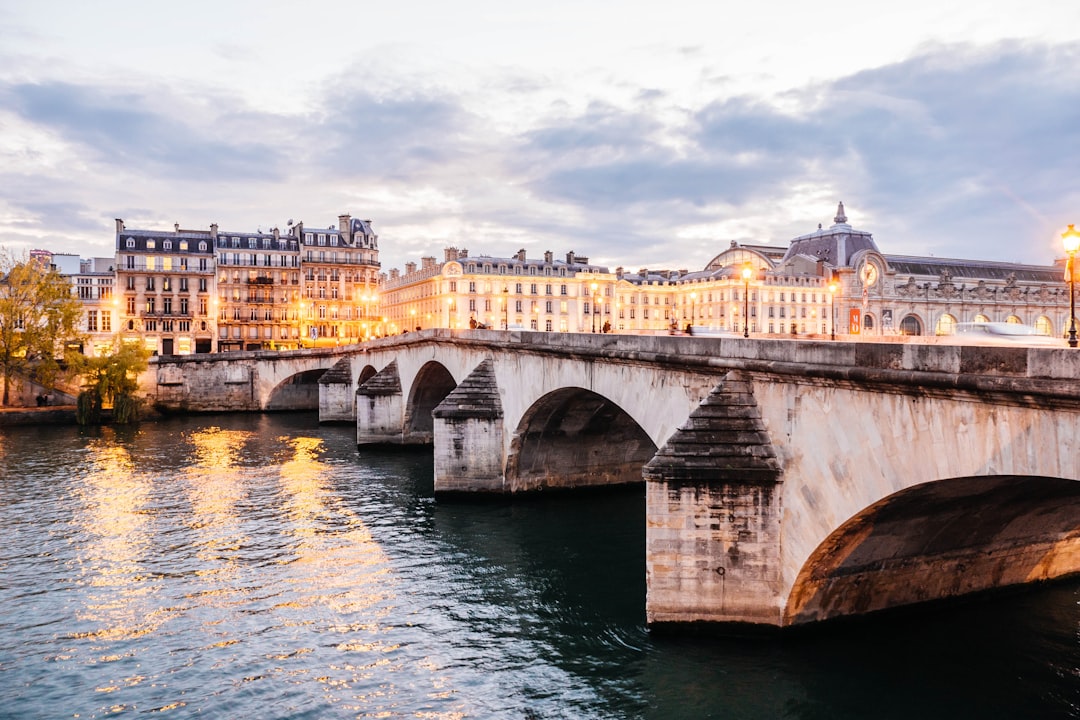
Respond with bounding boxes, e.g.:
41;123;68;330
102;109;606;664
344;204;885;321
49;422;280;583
143;330;1080;626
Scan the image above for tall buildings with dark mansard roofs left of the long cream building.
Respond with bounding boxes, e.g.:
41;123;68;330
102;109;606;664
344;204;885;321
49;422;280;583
61;215;383;355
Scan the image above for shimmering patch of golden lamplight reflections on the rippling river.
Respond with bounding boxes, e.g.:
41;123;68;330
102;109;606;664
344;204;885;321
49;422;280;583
59;427;460;718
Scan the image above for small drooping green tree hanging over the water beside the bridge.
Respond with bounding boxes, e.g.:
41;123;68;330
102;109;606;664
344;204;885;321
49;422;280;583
72;336;150;425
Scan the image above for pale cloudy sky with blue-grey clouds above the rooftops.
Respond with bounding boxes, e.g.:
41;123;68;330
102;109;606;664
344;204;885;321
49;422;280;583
0;0;1080;269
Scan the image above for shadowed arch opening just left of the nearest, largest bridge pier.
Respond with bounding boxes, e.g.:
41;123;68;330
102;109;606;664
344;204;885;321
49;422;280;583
507;388;657;491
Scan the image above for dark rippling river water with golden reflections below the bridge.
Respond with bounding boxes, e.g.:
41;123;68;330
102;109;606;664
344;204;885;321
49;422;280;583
0;413;1080;720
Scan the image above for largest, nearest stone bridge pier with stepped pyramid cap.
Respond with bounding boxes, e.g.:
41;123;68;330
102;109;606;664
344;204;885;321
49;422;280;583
644;372;783;625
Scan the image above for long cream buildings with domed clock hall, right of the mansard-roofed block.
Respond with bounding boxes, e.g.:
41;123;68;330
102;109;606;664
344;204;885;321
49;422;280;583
379;203;1069;339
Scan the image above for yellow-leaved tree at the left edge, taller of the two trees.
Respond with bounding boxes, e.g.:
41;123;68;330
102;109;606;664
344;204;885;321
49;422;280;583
0;248;82;405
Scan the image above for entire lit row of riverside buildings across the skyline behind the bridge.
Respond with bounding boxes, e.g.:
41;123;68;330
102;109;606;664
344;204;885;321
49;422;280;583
39;203;1069;354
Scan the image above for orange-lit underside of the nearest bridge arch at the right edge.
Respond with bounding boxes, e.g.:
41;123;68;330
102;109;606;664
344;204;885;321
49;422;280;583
783;475;1080;625
